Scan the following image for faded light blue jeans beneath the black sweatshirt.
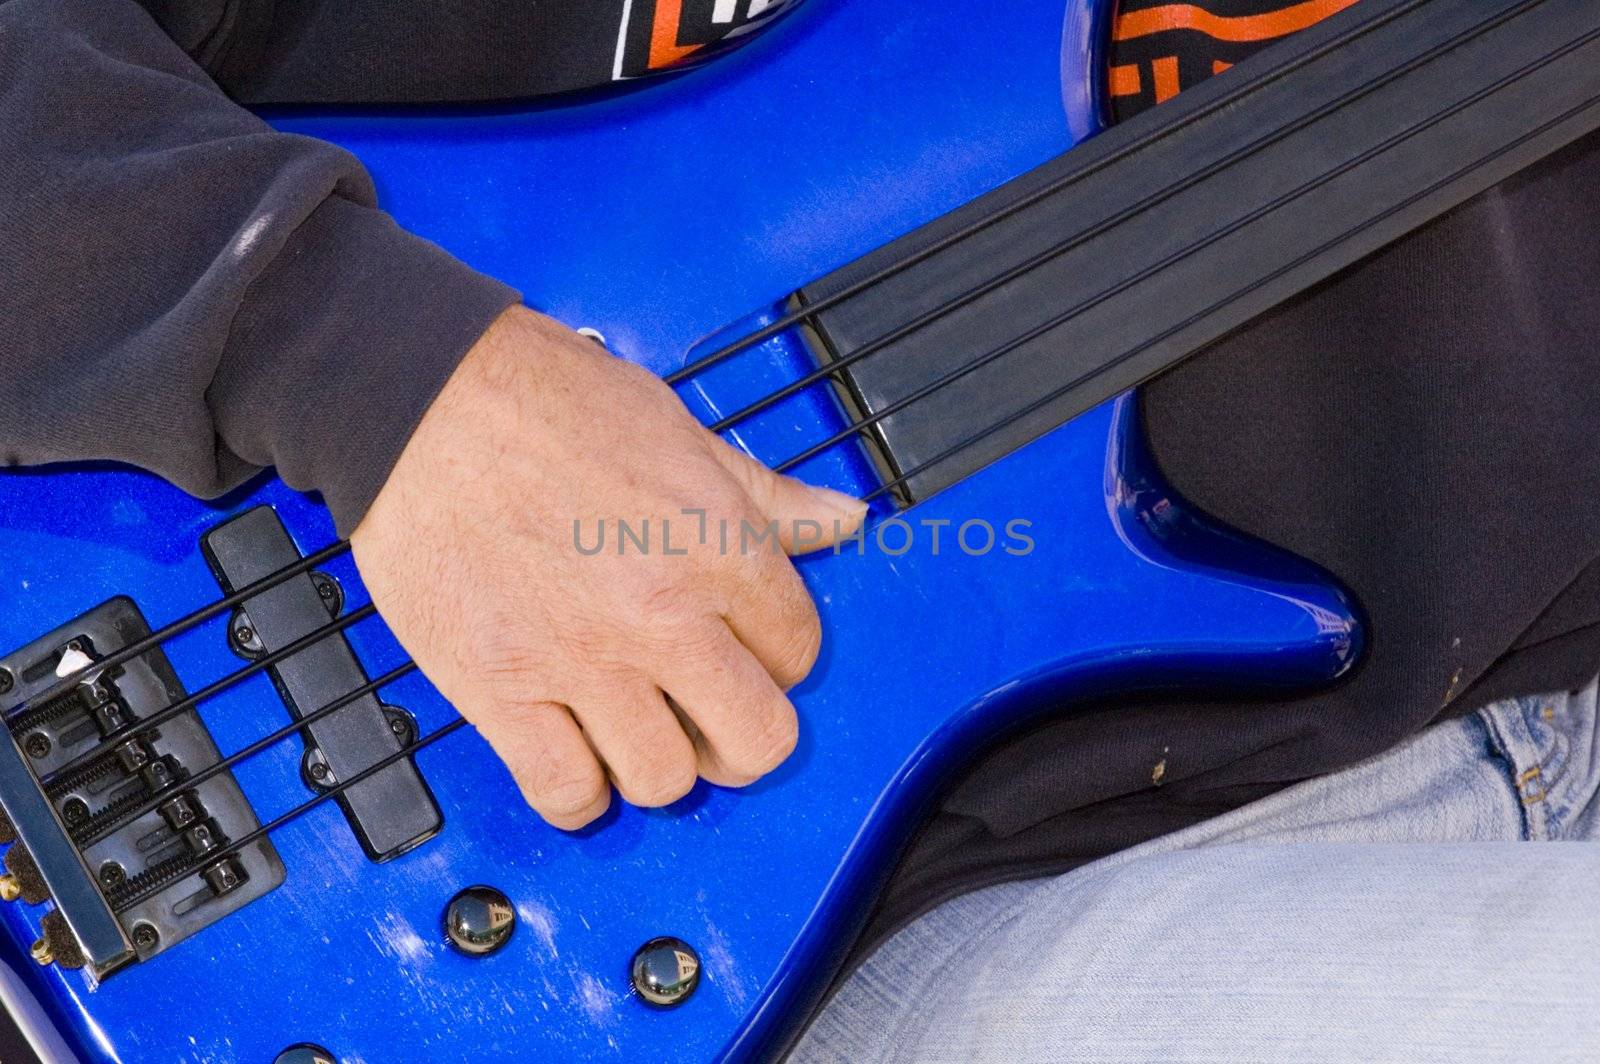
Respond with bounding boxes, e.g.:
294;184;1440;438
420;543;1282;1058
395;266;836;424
790;683;1600;1064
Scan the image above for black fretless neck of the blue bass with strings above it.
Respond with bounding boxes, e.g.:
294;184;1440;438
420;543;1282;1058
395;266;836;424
797;0;1600;504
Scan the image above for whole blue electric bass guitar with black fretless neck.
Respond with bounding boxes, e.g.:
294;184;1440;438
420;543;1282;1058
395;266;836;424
0;0;1600;1064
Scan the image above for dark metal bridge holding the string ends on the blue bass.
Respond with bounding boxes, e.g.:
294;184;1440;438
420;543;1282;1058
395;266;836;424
0;598;283;978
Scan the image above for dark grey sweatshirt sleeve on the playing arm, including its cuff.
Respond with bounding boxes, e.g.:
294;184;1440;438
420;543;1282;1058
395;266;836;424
0;0;517;534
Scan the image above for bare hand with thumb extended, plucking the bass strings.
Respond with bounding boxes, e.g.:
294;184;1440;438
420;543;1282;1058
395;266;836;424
350;307;866;829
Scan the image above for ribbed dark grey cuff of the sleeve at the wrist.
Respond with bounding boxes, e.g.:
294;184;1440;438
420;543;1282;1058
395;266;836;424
206;195;520;536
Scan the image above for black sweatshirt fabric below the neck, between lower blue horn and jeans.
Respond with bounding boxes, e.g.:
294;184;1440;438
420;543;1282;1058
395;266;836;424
858;124;1600;955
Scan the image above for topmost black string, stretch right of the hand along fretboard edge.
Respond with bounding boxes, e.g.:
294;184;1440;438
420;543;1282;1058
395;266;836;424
662;0;1433;384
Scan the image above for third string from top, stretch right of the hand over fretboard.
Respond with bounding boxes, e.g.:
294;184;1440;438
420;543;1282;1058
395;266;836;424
773;22;1595;480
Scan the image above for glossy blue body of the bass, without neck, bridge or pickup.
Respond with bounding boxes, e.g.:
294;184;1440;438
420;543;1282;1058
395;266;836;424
0;0;1358;1064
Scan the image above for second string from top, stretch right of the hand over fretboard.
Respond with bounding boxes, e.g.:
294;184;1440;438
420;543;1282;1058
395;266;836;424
707;0;1516;432
